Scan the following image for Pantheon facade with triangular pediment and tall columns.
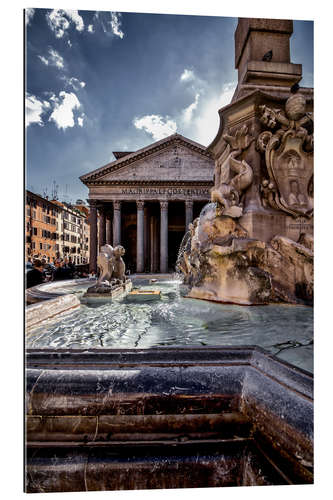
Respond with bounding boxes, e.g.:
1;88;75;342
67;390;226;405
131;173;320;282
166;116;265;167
80;134;214;273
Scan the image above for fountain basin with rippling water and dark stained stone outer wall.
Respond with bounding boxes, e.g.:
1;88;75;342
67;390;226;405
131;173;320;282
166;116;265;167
25;280;313;492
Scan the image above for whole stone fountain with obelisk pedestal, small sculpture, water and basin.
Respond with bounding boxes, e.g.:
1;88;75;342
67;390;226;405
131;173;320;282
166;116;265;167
26;18;313;492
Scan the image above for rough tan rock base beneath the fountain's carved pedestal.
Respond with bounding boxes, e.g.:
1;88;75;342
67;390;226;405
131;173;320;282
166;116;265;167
178;203;313;305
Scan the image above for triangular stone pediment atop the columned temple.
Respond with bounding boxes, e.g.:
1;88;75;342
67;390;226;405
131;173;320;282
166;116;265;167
80;134;214;185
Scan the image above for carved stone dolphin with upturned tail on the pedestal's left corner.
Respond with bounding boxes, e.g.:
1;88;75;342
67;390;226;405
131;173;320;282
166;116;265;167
211;125;254;218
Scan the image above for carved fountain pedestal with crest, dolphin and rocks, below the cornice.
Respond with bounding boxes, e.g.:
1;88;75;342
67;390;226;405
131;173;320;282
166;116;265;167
177;91;313;305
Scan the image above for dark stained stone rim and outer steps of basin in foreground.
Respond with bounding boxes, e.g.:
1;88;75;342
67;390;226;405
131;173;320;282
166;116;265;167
26;347;313;492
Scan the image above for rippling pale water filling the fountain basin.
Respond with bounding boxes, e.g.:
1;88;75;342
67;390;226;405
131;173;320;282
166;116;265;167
26;281;313;371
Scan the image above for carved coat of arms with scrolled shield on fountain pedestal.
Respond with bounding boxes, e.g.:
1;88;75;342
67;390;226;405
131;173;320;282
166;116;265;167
257;94;313;217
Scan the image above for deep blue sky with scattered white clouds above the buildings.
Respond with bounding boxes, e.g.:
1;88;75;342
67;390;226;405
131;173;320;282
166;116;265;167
25;9;313;202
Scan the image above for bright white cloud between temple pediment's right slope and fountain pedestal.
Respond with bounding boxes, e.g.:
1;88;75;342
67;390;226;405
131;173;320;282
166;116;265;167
192;82;237;146
